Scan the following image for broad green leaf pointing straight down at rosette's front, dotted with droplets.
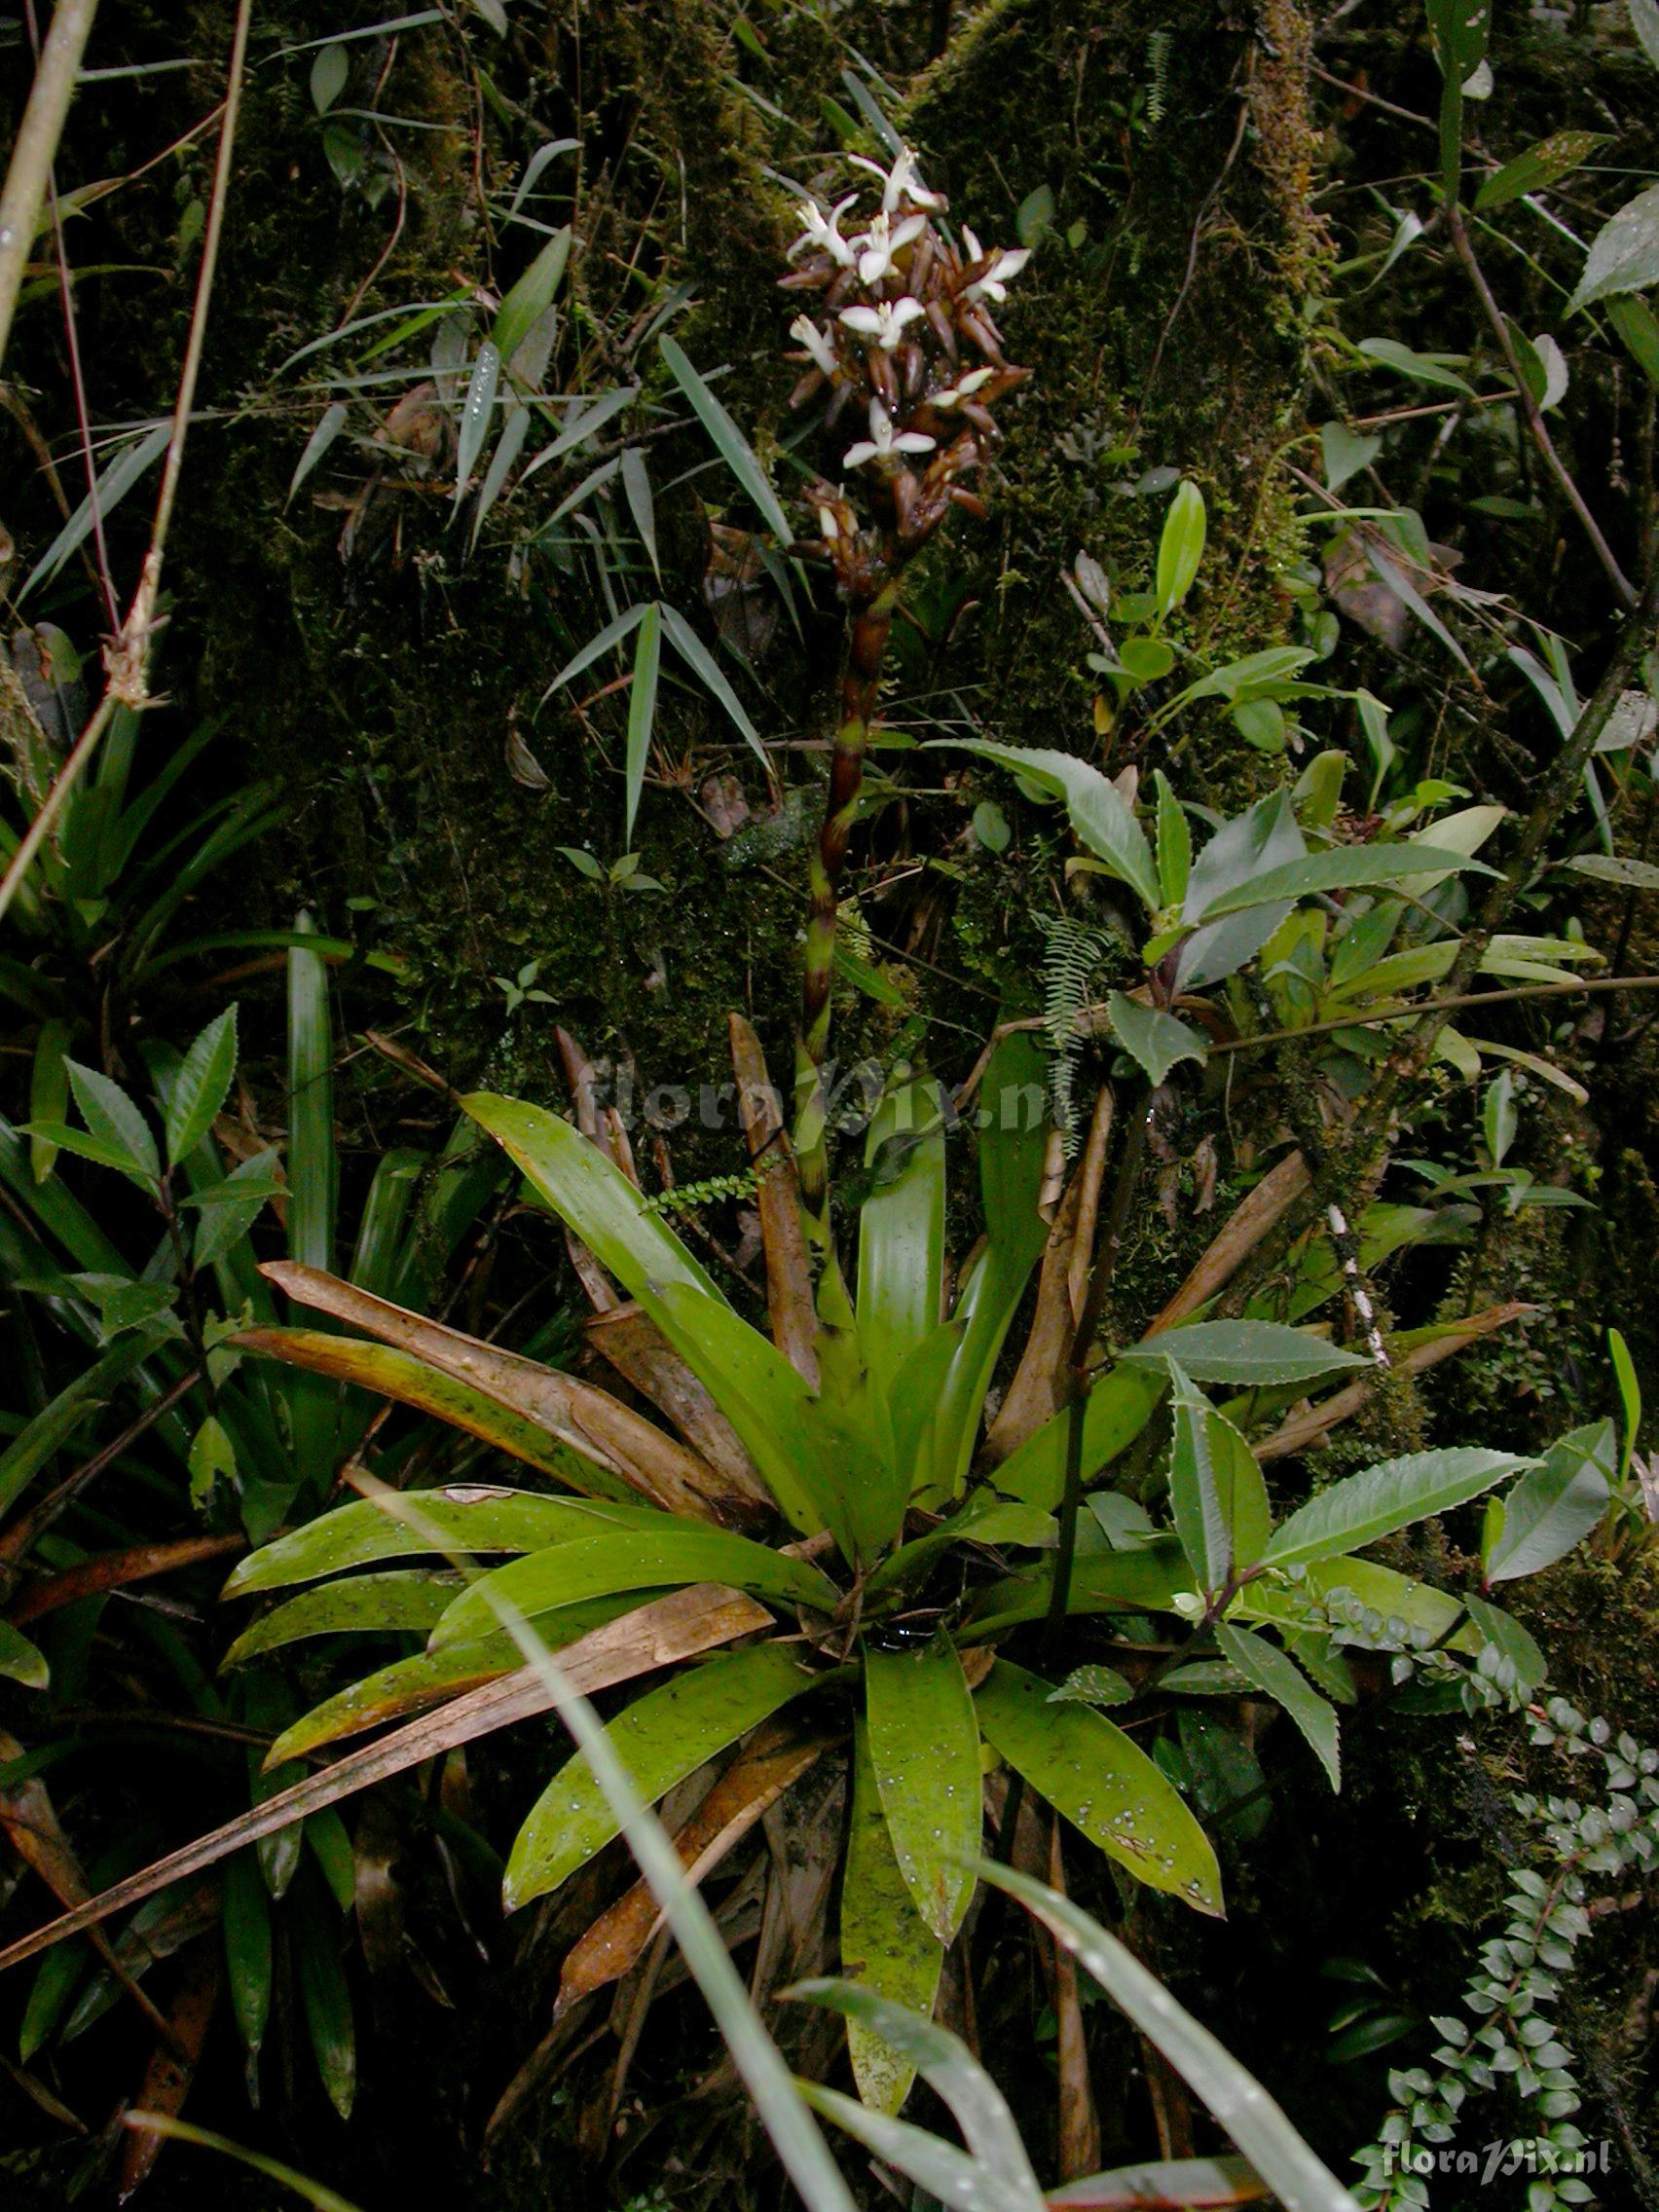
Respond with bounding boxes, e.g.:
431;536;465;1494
865;1635;984;1942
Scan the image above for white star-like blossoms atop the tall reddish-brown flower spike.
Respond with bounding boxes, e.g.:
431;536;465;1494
790;146;1031;469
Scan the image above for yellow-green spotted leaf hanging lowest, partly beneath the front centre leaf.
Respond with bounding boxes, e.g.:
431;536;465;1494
840;1721;944;2113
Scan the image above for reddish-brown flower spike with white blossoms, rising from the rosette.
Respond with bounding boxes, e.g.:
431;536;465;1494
783;148;1031;1214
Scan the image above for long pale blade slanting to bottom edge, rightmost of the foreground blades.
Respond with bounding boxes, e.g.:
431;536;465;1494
979;1867;1358;2212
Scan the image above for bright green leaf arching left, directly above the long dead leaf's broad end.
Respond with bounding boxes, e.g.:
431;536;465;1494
431;1513;838;1650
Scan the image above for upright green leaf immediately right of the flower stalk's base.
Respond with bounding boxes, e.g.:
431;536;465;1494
859;1077;944;1398
